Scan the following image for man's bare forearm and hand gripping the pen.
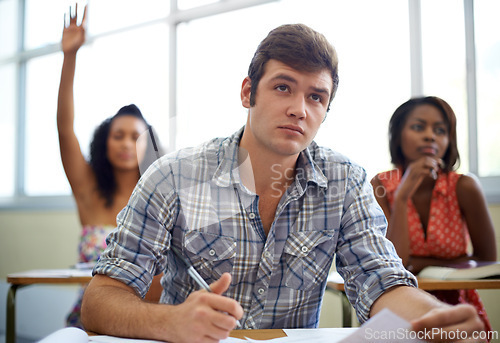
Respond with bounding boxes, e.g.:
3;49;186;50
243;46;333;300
82;274;243;343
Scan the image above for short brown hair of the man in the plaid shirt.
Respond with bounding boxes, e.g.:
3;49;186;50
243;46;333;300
248;24;339;110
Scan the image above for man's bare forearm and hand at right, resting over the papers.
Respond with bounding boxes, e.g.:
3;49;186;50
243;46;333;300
370;286;484;341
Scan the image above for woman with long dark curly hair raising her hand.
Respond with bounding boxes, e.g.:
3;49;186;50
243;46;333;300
57;5;159;327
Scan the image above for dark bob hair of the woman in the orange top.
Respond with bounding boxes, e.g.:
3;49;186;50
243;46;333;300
389;96;460;171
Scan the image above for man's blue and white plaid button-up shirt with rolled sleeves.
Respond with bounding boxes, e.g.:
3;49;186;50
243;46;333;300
94;126;416;329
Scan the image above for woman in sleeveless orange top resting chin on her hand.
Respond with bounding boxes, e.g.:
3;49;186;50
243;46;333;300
372;97;496;331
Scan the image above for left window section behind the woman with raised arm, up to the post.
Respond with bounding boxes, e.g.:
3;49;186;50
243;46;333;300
0;0;169;206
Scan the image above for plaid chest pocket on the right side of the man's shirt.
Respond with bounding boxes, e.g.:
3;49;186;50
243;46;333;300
284;230;335;291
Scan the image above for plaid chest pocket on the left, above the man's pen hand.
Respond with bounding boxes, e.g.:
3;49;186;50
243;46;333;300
183;231;236;284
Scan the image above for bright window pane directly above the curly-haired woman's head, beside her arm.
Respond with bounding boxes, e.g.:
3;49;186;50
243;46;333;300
75;24;169;156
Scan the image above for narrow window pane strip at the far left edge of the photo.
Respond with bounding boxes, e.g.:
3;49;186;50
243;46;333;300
0;64;17;197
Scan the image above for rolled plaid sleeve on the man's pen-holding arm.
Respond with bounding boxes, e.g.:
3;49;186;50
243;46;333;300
93;164;178;297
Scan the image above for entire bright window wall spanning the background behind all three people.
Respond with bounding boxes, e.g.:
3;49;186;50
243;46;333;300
0;0;500;207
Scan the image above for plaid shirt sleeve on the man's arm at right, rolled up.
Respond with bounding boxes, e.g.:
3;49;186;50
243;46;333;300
336;166;417;323
